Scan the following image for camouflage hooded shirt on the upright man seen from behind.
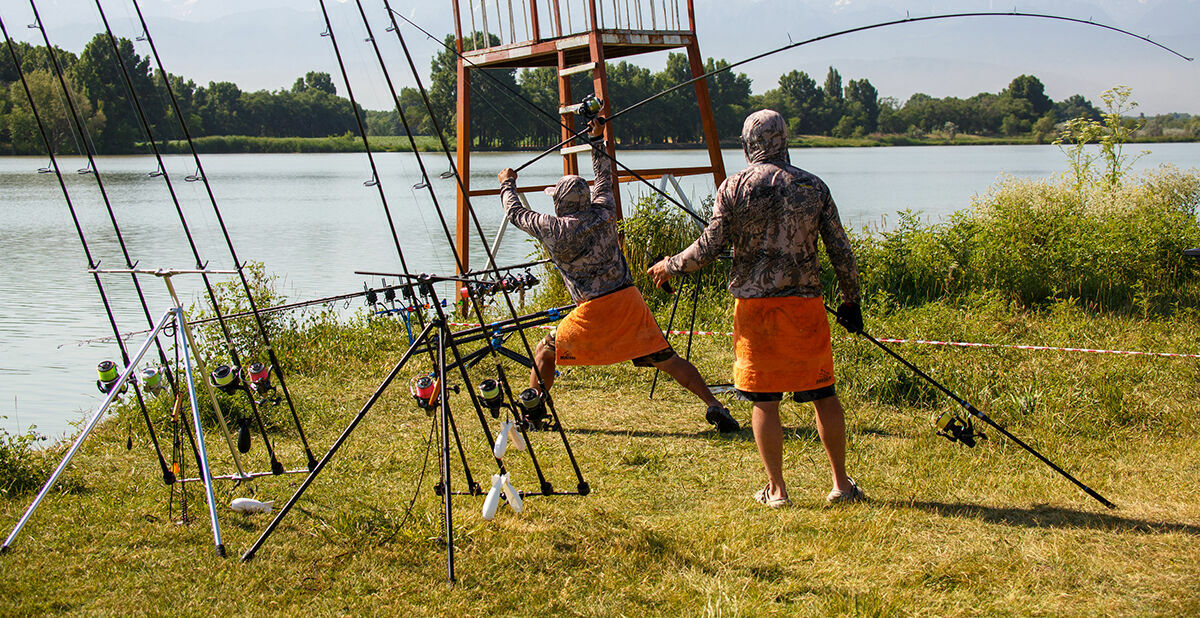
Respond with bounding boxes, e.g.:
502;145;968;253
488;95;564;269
666;109;858;302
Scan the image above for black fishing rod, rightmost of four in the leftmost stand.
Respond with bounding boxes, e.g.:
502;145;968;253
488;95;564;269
127;0;317;470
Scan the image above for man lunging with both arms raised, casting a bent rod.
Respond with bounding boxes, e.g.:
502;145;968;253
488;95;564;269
499;120;740;433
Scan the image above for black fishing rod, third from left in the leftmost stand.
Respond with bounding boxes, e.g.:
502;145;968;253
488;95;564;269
95;0;283;474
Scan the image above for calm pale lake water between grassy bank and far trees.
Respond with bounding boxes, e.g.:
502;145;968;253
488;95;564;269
7;144;1200;438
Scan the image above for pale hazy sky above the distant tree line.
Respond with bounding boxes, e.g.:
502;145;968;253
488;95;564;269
0;0;1200;114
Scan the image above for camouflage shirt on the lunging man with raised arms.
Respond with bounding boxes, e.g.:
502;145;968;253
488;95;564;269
500;140;634;304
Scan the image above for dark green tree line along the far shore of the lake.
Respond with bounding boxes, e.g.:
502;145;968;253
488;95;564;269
0;34;1200;154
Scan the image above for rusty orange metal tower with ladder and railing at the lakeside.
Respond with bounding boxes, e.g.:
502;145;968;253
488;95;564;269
451;0;725;268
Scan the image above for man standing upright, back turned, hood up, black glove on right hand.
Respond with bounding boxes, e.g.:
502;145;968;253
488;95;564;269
647;109;864;508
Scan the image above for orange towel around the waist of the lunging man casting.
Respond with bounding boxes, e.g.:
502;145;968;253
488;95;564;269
554;286;667;365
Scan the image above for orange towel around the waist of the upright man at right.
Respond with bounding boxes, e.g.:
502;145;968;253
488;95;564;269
733;296;834;392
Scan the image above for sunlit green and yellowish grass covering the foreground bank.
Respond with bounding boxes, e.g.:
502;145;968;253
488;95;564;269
0;298;1200;616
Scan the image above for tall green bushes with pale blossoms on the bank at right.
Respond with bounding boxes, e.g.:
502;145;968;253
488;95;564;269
849;167;1200;316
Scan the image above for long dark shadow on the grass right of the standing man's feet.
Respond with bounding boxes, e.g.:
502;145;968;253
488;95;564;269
878;500;1200;536
